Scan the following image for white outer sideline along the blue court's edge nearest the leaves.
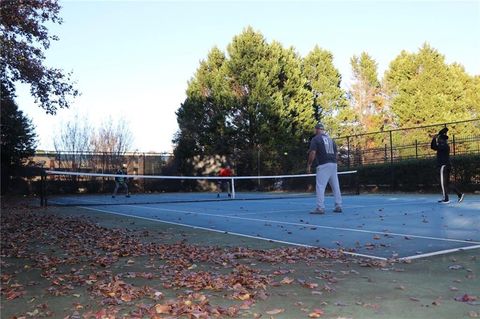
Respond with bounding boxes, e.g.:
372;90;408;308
76;206;389;261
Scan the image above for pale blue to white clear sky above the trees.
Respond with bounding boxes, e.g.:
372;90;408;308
16;0;480;152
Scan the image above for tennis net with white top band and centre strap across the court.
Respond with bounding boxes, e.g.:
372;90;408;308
41;171;359;206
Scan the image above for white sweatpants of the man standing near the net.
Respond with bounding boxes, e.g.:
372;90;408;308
316;163;342;209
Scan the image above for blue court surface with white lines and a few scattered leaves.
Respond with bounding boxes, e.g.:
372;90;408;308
50;194;480;260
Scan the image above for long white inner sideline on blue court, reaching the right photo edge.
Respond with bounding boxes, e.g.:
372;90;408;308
123;205;480;244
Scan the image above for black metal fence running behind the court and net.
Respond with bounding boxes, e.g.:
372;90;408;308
33;119;480;175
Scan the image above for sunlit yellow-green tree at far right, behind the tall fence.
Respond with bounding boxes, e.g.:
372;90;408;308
384;43;480;143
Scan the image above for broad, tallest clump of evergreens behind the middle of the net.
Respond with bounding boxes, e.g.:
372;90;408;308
175;28;315;174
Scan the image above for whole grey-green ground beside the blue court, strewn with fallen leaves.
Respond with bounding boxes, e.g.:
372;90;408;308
0;204;480;319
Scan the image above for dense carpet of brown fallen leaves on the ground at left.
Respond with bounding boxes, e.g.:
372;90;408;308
1;208;386;318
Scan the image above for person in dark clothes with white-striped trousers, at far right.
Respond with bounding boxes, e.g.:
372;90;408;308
430;127;464;204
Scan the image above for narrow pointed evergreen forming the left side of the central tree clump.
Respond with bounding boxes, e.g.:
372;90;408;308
174;48;233;172
